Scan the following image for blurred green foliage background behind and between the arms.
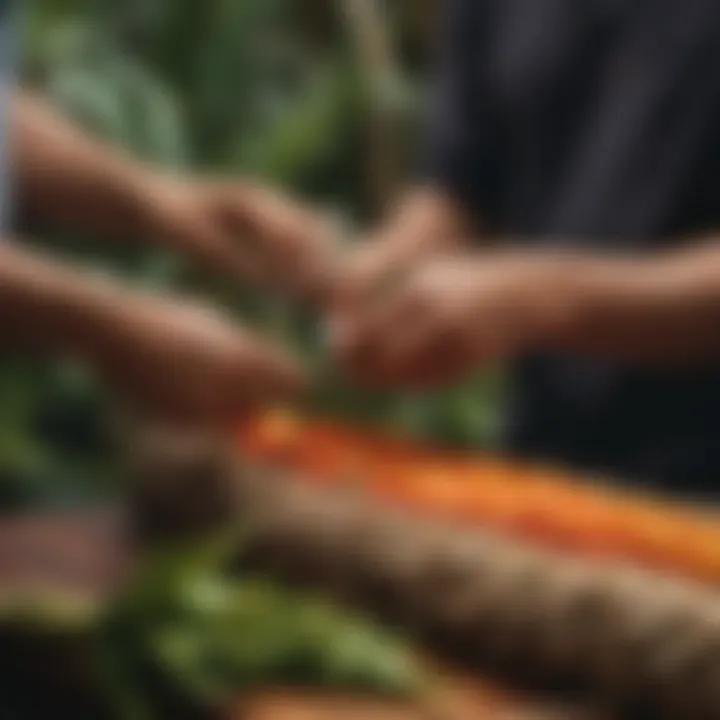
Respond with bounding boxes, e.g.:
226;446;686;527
0;0;503;504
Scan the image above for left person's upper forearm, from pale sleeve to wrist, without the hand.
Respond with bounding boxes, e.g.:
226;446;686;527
11;92;159;238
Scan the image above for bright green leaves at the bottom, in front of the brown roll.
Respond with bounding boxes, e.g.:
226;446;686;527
99;532;424;720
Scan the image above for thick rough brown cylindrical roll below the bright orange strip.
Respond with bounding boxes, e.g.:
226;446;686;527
135;437;720;720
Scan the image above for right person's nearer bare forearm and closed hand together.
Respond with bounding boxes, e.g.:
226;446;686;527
335;242;720;389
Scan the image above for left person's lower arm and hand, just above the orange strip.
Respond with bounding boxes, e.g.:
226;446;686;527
0;243;303;426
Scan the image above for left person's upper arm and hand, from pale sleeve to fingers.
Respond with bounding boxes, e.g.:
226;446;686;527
11;93;336;299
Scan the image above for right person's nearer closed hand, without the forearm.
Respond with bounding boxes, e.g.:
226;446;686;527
333;254;562;389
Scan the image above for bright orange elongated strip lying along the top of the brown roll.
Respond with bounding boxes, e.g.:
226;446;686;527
239;413;720;584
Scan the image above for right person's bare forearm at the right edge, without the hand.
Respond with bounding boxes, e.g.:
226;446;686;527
530;243;720;364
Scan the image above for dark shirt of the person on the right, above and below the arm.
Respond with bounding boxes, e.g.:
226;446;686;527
430;0;720;491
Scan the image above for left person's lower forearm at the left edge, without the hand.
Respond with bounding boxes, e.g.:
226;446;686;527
0;241;121;362
